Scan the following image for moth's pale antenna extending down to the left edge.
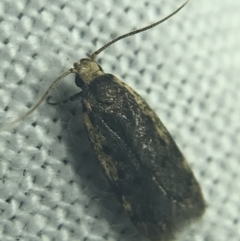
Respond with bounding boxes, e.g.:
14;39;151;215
0;68;76;131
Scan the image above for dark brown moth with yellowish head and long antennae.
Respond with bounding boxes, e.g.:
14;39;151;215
2;1;205;241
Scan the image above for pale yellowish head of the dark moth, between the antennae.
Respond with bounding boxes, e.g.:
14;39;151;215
73;59;104;84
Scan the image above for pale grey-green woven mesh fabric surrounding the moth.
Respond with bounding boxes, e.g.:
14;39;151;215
0;0;240;241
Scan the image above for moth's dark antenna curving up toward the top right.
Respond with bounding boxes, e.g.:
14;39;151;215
91;0;190;61
